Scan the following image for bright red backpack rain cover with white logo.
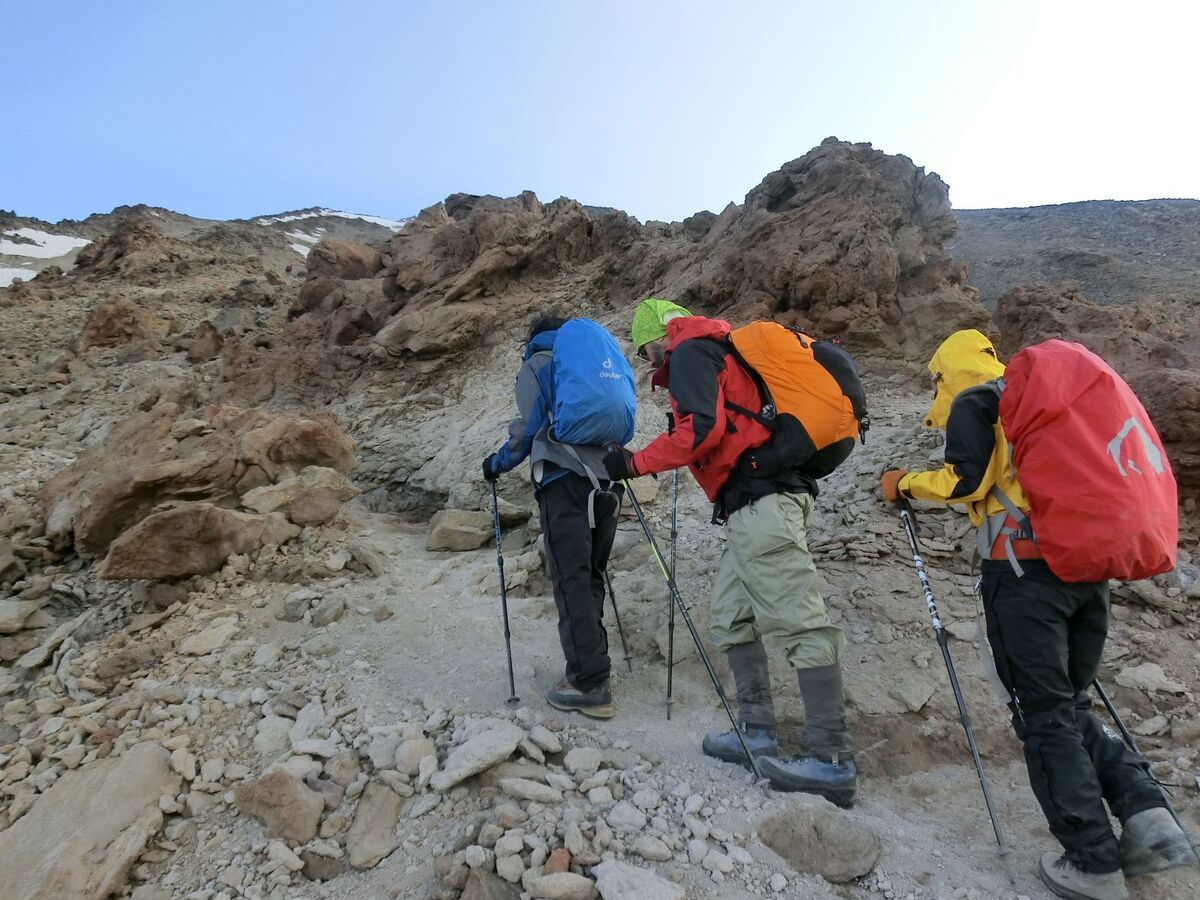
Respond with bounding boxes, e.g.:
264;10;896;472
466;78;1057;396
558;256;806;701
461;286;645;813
1000;341;1180;582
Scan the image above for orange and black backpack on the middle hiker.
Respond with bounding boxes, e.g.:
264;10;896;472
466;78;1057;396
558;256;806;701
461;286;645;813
725;322;870;478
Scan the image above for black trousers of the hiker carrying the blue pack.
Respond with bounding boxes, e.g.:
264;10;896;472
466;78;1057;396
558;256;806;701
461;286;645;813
538;472;623;691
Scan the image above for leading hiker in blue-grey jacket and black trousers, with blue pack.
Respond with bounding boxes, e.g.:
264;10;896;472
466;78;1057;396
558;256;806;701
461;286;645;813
484;314;634;719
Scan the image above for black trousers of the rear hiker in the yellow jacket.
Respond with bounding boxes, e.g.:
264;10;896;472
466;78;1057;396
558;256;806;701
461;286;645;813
983;560;1164;872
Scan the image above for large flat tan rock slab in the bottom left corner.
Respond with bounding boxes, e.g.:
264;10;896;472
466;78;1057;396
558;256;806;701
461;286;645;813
0;743;170;900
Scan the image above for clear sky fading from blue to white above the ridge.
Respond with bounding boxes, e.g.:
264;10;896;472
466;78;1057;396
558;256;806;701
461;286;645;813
0;0;1200;221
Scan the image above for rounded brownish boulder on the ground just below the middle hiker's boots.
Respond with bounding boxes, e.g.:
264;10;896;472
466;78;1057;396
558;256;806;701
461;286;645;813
758;800;880;884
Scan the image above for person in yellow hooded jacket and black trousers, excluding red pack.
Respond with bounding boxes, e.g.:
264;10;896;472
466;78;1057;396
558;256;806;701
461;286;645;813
881;330;1194;900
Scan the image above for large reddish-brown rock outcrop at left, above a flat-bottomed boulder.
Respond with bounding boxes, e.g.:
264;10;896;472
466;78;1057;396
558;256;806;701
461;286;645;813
40;403;354;556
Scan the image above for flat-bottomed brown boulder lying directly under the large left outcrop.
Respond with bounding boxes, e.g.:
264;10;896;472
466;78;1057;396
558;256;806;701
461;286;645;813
100;503;300;578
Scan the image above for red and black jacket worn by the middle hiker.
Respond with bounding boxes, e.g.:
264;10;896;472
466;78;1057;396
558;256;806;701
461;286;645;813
634;316;770;502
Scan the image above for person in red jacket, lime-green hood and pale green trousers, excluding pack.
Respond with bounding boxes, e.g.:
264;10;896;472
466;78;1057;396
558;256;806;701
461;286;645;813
605;298;857;805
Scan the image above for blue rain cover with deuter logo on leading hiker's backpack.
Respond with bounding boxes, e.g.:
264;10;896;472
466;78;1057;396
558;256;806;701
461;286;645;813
553;319;637;446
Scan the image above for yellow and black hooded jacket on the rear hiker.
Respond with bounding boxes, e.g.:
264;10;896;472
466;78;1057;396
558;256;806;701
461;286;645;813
899;329;1030;527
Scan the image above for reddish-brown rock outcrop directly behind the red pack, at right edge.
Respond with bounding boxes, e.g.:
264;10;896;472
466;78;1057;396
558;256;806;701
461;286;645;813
995;284;1200;496
